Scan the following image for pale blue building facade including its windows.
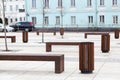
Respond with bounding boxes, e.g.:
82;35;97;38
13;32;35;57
25;0;120;28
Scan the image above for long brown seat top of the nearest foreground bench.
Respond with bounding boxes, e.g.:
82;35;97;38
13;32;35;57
0;54;63;61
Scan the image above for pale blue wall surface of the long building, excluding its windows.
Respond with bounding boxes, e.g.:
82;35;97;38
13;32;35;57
25;0;120;27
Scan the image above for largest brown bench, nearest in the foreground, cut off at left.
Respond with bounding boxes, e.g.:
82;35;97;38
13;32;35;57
0;53;64;73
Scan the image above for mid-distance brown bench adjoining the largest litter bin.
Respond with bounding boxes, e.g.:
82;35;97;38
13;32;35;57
46;42;80;52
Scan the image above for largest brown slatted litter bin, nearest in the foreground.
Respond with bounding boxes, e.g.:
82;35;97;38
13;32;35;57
79;42;94;73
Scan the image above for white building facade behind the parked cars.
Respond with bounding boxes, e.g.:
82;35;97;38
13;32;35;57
0;0;26;24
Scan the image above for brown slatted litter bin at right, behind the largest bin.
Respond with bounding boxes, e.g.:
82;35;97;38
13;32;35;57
101;34;110;52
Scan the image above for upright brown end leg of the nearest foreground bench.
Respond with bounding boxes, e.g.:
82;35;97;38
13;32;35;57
55;55;64;73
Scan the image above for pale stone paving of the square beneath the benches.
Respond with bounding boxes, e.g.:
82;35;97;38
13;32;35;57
0;32;120;80
